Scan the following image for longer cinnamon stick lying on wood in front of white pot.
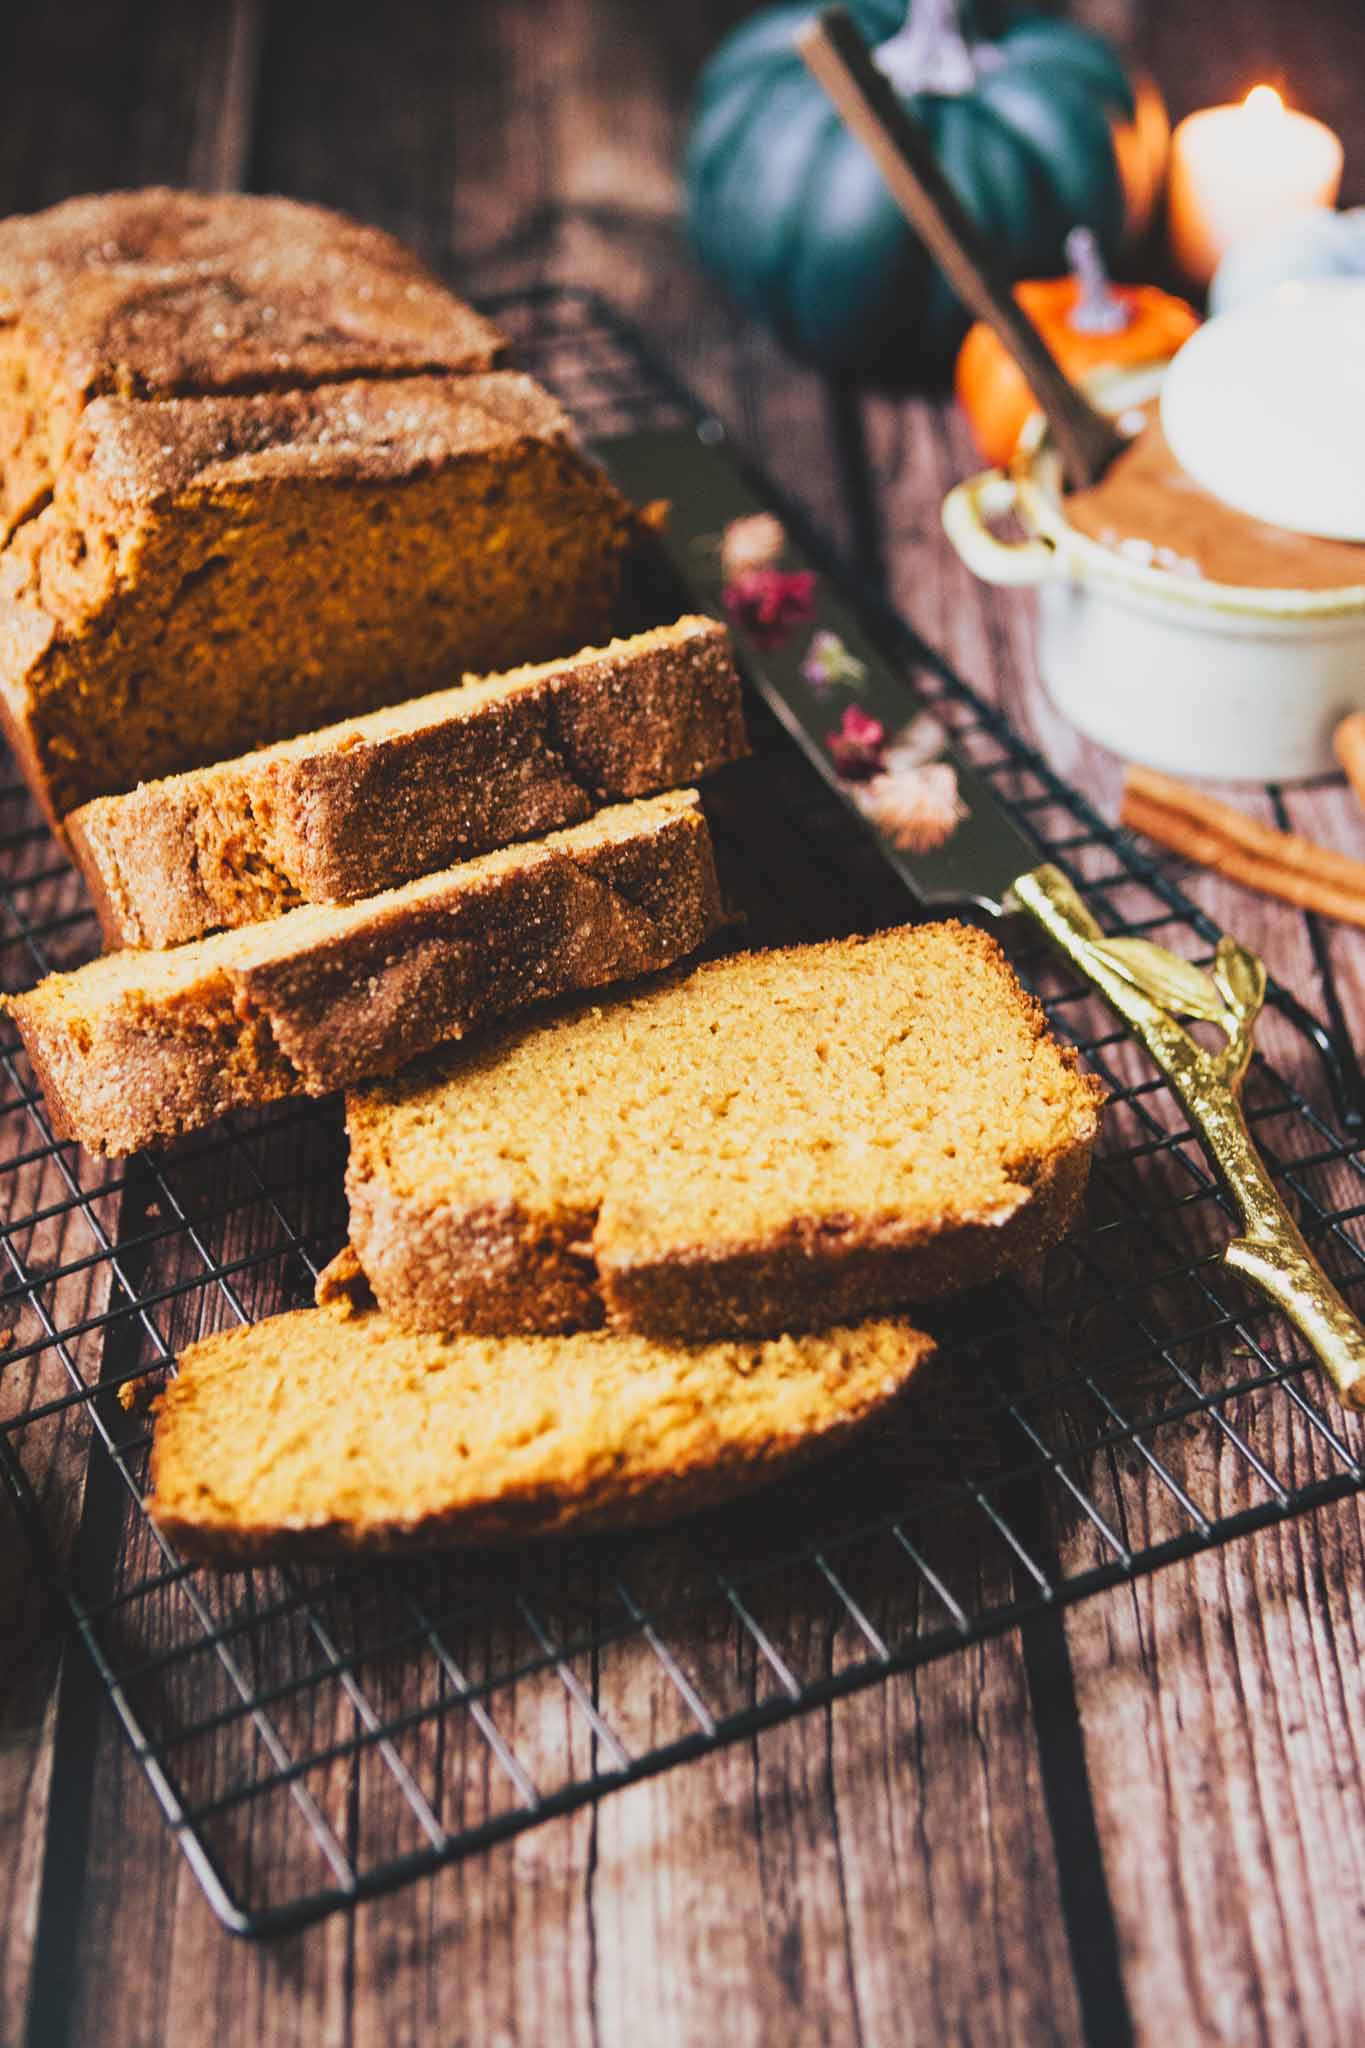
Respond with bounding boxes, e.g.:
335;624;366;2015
1119;768;1365;926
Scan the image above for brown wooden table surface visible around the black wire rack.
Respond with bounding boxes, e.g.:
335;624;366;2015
0;0;1365;2048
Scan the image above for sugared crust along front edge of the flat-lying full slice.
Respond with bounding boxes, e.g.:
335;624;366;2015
346;926;1105;1339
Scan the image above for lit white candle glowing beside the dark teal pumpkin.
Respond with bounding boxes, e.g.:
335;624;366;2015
1166;86;1342;285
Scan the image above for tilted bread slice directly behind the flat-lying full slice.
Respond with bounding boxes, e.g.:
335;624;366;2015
6;791;720;1153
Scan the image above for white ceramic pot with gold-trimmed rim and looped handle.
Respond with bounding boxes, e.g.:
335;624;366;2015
943;369;1365;782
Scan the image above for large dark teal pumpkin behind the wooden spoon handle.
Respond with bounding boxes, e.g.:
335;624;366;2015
684;0;1166;385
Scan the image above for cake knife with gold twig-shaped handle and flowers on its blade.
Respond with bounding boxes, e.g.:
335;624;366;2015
596;420;1365;1409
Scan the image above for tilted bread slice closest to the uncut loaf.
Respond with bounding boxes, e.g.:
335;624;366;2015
65;616;745;946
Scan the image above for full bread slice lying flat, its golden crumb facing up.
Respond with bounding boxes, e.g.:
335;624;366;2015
346;924;1103;1339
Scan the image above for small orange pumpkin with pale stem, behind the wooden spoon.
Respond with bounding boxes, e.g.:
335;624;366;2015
954;227;1199;467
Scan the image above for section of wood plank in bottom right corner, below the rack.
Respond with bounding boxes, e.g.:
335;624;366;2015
1068;1503;1365;2044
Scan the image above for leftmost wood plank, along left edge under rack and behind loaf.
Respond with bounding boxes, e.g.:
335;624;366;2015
0;0;270;2040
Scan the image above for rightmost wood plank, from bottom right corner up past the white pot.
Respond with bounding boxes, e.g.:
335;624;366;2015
874;292;1365;2042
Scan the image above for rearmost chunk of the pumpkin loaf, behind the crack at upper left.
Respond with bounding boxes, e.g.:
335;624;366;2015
0;186;503;543
